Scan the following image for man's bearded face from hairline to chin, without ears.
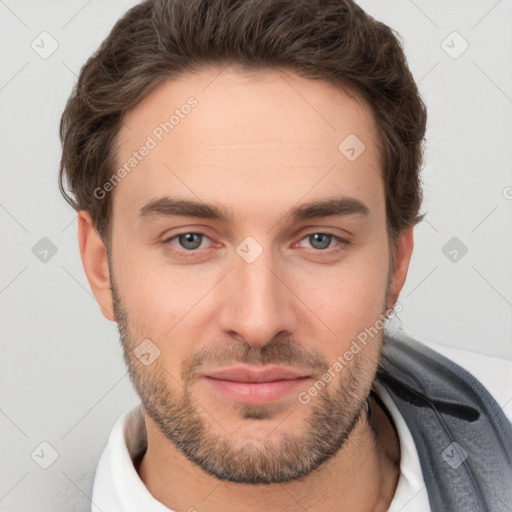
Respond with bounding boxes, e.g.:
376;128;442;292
109;68;396;483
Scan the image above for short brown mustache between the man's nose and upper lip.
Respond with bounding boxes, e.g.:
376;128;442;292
182;337;329;382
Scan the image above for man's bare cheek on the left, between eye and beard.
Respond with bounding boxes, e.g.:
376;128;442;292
113;242;218;368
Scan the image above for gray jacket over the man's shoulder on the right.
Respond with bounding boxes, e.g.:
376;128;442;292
377;334;512;512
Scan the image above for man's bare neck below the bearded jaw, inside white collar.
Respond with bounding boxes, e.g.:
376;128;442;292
138;398;400;512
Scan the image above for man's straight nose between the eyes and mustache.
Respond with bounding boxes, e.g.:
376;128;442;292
219;241;298;346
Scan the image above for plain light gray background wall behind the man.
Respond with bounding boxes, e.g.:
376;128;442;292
0;0;512;512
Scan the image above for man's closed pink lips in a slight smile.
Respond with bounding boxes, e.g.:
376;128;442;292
200;365;312;405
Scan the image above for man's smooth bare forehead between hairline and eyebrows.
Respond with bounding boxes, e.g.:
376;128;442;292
113;67;383;224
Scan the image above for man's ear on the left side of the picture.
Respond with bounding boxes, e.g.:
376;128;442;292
78;210;115;322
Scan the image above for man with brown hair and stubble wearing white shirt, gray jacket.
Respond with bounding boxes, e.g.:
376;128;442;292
61;0;512;512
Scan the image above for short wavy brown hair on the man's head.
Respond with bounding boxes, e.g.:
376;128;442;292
59;0;427;244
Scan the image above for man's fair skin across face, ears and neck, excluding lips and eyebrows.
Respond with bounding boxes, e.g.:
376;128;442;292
78;67;413;512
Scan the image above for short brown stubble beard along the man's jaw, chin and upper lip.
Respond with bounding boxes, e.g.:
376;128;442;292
111;273;381;484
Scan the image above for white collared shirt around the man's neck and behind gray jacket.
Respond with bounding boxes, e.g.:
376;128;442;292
91;343;512;512
